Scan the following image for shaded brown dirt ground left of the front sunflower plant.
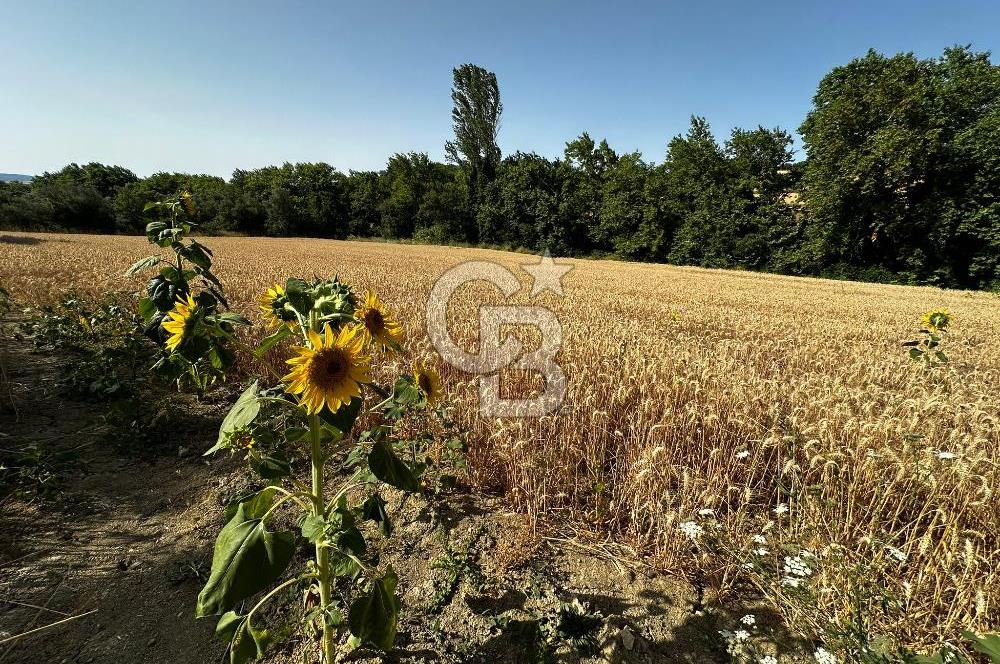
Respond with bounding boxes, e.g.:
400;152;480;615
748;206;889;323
0;334;223;664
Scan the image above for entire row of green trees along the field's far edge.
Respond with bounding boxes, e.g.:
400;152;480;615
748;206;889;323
0;47;1000;289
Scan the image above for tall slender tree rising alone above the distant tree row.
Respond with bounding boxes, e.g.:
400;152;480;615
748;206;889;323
444;64;503;242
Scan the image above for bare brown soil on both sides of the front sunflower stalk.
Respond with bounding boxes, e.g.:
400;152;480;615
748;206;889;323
0;333;726;664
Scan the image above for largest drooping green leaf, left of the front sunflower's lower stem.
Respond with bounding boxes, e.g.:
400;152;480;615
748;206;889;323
195;504;295;618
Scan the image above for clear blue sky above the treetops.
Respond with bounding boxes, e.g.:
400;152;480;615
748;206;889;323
0;0;1000;176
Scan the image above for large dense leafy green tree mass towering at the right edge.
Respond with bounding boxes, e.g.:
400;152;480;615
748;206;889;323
800;47;1000;287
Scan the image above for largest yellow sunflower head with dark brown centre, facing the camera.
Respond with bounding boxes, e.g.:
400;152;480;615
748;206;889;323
282;325;372;415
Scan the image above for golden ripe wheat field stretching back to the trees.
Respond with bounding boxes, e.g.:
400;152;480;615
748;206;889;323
0;235;1000;645
